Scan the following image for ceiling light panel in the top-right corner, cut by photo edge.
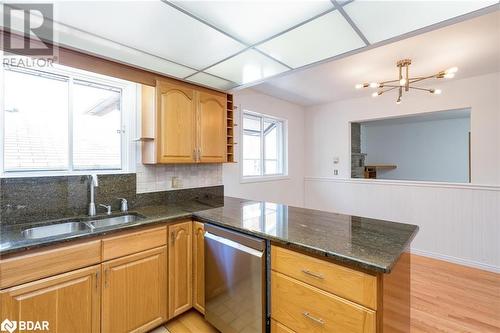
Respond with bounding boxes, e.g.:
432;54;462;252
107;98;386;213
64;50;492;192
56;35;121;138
344;0;498;43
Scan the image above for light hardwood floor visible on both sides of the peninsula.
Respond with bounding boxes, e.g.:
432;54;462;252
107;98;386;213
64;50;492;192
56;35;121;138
151;255;500;333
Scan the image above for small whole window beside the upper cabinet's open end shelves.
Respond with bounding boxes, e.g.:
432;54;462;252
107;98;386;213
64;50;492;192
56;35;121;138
241;111;287;181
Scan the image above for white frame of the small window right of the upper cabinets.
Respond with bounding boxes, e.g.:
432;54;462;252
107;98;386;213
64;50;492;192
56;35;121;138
239;109;289;184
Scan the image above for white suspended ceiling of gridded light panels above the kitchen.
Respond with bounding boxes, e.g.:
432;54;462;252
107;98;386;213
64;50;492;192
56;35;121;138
1;0;499;94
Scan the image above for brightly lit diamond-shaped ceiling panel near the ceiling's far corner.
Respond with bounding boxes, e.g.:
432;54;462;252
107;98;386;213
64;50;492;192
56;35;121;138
205;50;288;84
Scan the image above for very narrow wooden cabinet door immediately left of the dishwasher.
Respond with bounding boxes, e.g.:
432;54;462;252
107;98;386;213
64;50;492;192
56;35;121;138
193;222;205;313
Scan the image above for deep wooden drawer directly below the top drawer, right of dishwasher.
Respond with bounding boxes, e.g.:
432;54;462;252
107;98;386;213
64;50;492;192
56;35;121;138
271;272;376;333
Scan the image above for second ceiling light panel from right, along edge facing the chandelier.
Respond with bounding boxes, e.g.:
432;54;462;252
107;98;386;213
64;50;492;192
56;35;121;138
257;10;365;68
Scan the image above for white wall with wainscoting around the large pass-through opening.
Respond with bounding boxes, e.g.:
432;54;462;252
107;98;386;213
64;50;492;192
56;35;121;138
304;73;500;271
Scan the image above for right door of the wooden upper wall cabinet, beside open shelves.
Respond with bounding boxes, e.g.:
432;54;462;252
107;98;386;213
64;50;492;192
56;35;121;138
198;92;227;163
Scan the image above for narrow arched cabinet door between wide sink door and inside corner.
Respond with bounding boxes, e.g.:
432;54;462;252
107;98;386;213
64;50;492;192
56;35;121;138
168;221;193;319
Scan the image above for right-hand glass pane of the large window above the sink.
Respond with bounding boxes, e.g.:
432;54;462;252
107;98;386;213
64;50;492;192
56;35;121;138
73;80;121;169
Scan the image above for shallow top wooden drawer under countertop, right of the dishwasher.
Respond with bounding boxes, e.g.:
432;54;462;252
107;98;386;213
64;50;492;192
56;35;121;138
271;246;377;310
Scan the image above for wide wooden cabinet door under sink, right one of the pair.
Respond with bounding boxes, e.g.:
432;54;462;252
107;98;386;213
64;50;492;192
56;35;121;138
102;246;167;333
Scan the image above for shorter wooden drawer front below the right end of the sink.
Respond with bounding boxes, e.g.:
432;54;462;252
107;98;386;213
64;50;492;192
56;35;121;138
102;226;167;261
